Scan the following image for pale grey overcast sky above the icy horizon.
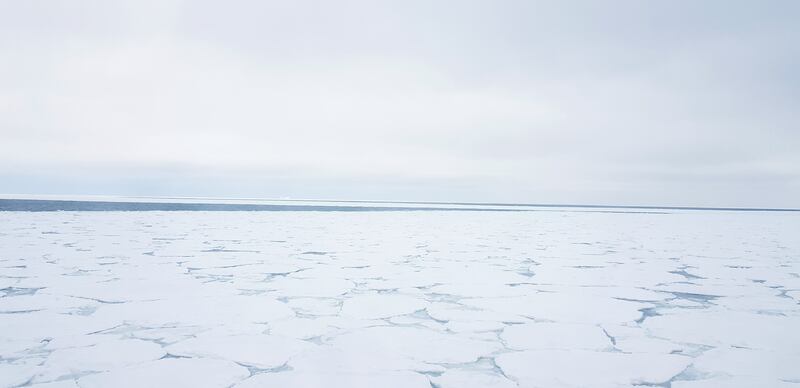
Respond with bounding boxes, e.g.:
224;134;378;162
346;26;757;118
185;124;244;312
0;0;800;208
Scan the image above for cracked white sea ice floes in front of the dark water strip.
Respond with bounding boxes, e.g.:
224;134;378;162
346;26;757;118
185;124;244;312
0;211;800;388
